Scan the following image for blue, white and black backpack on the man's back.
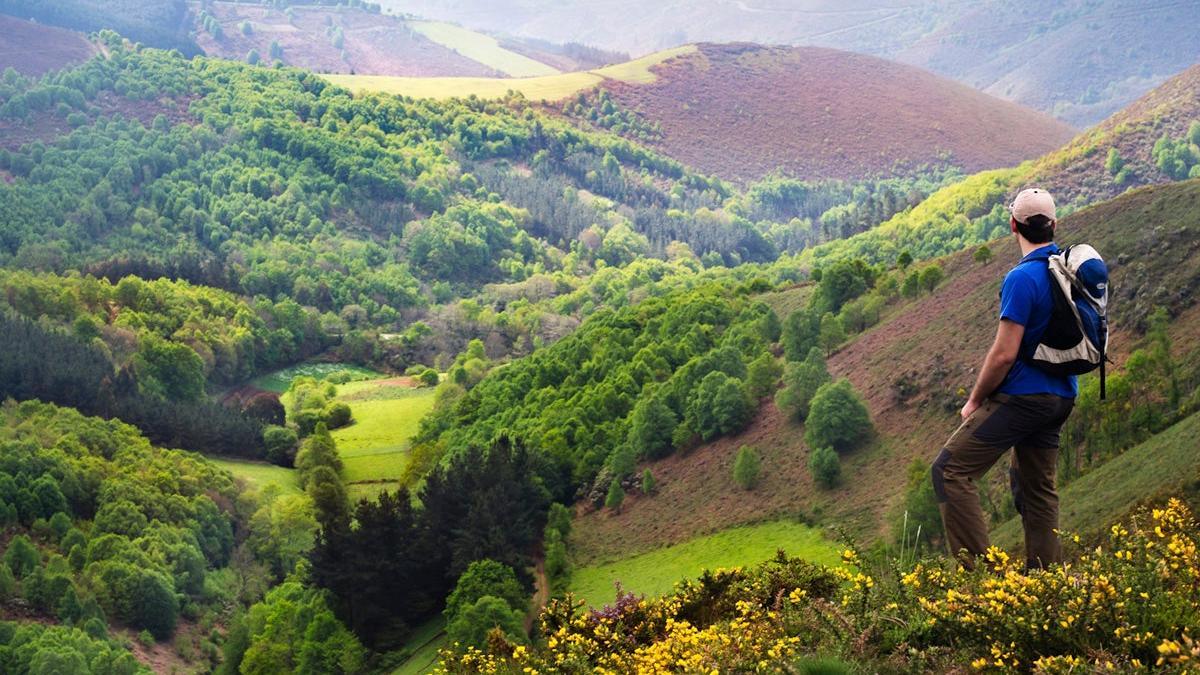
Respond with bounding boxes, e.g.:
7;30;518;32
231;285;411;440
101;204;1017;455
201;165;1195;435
1028;244;1109;399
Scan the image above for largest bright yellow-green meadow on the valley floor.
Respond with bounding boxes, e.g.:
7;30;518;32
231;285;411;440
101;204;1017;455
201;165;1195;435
332;380;433;500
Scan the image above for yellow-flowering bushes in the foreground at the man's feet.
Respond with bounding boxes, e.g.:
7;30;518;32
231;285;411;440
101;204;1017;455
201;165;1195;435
443;500;1200;673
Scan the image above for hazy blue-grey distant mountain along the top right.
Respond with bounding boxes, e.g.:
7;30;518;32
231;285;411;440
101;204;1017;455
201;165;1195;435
383;0;1200;125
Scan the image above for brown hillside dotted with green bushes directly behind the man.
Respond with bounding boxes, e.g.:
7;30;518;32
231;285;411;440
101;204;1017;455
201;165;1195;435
571;180;1200;565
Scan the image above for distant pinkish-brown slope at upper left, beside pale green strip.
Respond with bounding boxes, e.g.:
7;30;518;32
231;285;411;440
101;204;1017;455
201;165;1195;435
192;2;500;77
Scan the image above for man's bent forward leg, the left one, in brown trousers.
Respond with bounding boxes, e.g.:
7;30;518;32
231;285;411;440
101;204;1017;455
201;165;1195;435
931;399;1012;569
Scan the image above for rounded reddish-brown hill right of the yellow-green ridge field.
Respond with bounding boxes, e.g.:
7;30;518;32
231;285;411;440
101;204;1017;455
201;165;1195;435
595;43;1073;180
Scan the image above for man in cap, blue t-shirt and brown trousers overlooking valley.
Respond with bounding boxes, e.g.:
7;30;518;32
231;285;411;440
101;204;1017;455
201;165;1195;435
932;189;1078;569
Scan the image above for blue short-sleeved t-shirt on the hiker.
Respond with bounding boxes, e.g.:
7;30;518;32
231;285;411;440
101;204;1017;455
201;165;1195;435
997;243;1079;399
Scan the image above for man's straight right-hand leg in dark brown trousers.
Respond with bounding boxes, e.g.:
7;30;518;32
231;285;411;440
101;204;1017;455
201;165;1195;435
1015;443;1062;569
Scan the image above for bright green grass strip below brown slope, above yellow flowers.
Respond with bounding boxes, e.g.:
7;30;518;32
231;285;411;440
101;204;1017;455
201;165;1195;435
569;520;841;607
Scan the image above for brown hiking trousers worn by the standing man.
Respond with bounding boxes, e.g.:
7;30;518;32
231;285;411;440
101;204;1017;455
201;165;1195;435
932;394;1075;569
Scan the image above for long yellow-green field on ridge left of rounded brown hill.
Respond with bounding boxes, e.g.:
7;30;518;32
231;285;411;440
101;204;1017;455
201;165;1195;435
322;44;696;101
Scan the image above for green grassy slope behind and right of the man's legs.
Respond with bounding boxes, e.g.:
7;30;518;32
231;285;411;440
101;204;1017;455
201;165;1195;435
992;412;1200;548
